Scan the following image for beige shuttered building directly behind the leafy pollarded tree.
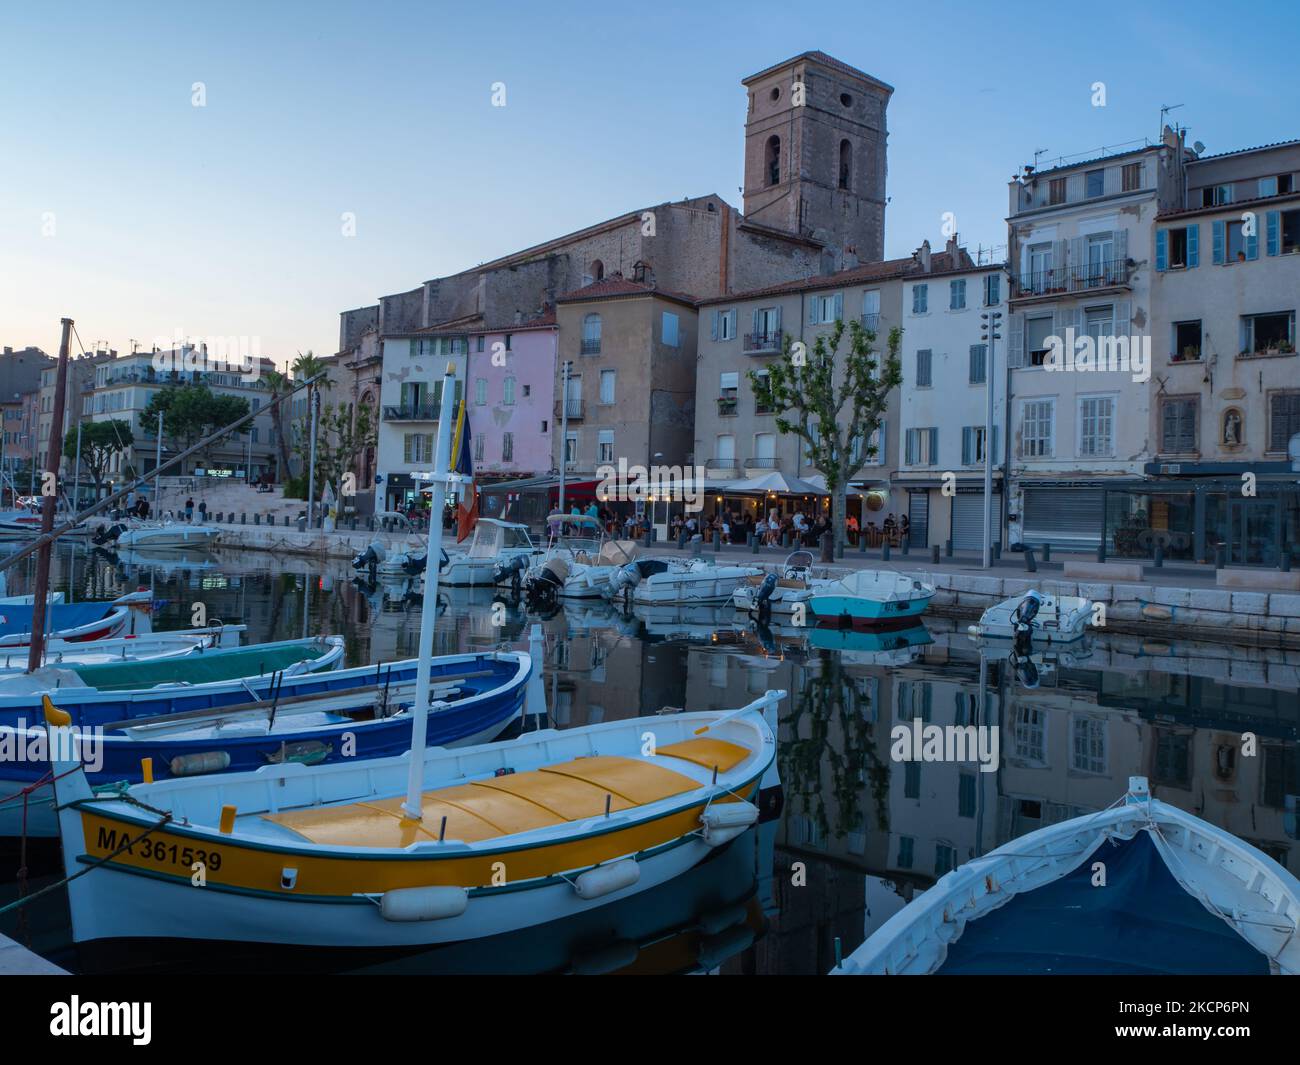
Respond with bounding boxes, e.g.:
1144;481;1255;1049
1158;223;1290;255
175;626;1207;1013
694;241;970;524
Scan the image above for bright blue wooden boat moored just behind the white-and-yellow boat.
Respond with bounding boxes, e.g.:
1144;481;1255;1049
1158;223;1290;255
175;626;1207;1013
0;649;532;835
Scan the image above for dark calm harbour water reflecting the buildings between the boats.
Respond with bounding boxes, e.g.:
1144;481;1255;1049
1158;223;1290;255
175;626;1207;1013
0;547;1300;973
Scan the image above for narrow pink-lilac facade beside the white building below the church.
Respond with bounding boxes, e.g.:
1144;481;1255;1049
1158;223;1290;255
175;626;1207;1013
465;311;558;485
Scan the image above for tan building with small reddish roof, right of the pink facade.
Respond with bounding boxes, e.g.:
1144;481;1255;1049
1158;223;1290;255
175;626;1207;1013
553;274;698;491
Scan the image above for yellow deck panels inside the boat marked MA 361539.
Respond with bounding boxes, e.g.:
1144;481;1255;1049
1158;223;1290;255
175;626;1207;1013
261;737;750;848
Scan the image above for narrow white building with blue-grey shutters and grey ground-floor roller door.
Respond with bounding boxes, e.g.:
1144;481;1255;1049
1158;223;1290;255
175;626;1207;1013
889;264;1010;551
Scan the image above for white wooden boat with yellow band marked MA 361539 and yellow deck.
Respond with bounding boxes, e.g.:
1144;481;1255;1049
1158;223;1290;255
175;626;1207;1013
47;692;785;947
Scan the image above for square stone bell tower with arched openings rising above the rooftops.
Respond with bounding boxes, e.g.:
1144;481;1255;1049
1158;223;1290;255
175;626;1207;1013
741;52;893;263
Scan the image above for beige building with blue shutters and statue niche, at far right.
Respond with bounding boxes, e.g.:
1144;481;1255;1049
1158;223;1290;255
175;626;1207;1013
1149;140;1300;566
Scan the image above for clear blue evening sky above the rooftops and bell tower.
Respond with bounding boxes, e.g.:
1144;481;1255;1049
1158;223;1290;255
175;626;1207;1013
0;0;1300;360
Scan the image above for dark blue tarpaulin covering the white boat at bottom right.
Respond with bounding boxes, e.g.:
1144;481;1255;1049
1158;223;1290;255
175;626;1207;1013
937;832;1269;975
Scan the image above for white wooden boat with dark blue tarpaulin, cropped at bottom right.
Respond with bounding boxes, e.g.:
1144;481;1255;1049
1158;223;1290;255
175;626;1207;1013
832;776;1300;975
